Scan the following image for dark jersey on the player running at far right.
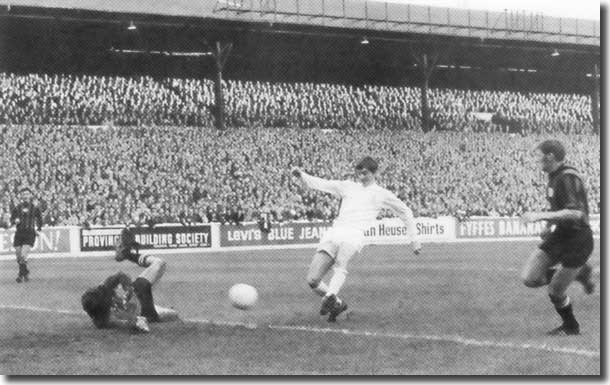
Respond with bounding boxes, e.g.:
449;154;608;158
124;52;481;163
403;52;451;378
547;166;589;230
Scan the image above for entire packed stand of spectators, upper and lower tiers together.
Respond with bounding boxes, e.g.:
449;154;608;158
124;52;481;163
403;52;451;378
0;73;600;226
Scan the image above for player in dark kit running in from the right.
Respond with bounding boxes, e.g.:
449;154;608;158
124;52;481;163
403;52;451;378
522;140;595;335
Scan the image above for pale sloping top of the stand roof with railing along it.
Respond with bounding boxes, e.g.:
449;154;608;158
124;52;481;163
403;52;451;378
0;0;600;47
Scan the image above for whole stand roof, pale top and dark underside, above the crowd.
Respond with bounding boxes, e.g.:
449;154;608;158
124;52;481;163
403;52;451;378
0;0;600;93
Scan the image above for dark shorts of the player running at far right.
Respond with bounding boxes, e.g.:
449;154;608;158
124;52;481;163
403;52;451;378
539;227;593;268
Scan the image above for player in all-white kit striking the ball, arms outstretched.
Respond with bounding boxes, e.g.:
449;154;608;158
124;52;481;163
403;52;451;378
292;156;421;322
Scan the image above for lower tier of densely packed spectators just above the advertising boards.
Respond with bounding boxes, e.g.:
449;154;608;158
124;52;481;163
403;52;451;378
0;124;600;226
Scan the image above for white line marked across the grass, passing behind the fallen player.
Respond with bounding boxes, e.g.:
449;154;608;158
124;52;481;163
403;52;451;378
0;305;600;358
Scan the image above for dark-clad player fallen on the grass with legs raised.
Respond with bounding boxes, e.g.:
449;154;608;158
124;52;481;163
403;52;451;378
81;229;178;332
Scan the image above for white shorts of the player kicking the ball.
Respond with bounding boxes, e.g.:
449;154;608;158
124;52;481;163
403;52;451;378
317;227;364;267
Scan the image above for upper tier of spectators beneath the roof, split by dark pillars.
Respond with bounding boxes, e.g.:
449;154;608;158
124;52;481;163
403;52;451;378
0;73;593;134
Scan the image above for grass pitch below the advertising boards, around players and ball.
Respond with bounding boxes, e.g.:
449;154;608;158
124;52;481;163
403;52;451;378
0;242;600;375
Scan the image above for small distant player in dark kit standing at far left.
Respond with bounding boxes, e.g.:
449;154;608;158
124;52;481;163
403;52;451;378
11;187;42;283
